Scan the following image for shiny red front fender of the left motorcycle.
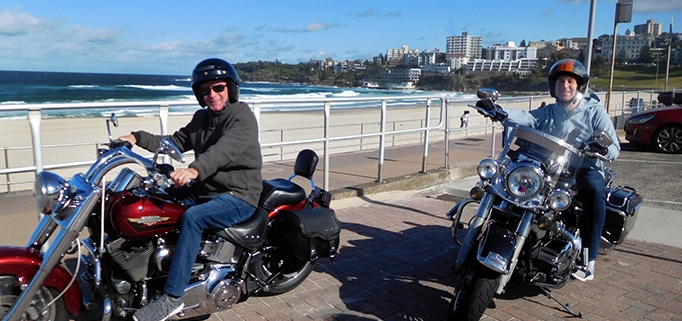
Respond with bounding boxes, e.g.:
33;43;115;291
0;246;83;315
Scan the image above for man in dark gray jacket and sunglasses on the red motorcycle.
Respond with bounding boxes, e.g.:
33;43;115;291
120;58;263;321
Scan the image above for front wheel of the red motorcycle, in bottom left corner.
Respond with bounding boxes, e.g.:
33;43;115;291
0;275;69;321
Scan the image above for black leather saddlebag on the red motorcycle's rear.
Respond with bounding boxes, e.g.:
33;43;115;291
272;207;341;261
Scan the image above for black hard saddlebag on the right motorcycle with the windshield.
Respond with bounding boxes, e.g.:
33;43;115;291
602;186;643;245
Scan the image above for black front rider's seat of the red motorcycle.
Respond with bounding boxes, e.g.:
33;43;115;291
210;208;268;251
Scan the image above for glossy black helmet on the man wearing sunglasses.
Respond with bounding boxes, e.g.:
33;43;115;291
192;58;239;107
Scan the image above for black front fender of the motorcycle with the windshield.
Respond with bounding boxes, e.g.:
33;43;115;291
477;221;516;274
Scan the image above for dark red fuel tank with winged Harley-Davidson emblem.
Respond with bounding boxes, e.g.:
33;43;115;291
108;192;187;239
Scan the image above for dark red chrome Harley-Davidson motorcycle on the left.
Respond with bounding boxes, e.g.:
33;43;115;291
0;115;340;320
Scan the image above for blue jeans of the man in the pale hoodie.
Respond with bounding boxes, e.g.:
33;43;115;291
577;168;606;261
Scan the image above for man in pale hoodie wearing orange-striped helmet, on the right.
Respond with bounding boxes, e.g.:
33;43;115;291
477;59;620;281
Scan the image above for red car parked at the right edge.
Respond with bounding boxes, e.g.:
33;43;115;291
625;106;682;154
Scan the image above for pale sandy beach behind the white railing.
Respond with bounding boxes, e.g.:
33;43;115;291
0;89;636;192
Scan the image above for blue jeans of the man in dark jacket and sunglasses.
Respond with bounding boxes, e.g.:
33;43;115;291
164;194;256;297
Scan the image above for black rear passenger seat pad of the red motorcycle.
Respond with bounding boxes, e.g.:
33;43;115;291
258;178;305;212
